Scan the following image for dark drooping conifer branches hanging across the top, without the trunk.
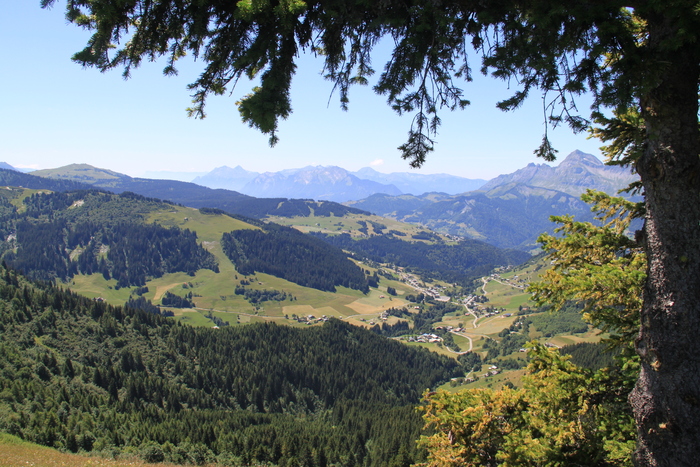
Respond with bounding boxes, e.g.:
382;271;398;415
42;0;643;166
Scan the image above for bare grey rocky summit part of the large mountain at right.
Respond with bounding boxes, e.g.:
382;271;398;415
481;151;638;196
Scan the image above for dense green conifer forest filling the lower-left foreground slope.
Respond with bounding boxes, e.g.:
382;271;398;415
0;266;458;467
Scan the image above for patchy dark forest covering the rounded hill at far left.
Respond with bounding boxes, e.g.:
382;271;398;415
0;190;218;287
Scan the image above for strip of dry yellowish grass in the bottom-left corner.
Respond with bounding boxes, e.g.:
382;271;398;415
0;433;183;467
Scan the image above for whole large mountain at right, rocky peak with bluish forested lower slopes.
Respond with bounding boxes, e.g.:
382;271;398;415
347;151;636;250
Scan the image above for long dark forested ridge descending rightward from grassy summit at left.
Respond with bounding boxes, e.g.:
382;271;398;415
28;164;363;218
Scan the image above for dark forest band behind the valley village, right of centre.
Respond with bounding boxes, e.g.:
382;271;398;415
312;233;531;282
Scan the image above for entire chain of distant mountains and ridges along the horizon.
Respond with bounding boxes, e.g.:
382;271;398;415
17;151;637;251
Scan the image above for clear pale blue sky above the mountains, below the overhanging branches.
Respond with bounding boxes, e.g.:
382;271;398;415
0;0;602;179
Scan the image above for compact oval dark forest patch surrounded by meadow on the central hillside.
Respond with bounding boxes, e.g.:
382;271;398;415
221;224;369;293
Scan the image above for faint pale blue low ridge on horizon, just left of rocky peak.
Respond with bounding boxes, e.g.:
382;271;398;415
353;167;486;195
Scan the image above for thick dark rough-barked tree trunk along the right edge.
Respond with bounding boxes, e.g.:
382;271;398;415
630;12;700;466
